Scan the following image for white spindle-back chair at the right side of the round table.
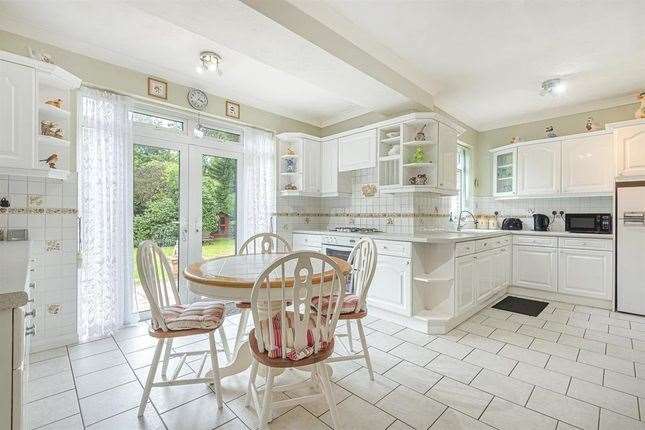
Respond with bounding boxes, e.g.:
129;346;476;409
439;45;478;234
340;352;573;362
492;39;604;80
327;238;377;381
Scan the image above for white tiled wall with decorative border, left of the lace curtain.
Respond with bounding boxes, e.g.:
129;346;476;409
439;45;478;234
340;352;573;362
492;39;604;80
0;175;78;348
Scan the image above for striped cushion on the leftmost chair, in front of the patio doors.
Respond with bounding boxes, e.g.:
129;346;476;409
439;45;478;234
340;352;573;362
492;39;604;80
161;302;224;330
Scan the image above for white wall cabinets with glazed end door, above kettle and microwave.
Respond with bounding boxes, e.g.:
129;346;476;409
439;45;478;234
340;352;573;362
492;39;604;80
491;131;615;198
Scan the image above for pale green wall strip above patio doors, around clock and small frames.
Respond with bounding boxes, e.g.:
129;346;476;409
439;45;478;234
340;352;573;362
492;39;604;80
0;30;320;136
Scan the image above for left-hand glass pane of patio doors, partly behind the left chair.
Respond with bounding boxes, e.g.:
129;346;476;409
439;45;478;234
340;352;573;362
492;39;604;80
133;144;179;312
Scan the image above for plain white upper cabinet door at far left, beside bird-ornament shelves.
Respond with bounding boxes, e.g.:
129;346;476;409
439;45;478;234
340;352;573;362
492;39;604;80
0;60;36;169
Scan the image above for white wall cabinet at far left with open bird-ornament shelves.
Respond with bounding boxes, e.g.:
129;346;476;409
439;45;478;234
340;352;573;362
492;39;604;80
0;51;81;179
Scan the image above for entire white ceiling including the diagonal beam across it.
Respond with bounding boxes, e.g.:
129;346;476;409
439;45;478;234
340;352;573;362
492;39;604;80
0;0;645;130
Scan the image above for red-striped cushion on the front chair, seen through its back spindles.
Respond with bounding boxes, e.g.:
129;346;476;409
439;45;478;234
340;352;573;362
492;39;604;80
254;312;330;361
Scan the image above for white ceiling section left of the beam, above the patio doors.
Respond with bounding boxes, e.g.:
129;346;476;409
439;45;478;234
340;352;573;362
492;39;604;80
0;0;409;126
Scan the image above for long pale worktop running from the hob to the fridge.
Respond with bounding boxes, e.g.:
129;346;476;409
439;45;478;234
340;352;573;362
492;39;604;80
293;229;613;243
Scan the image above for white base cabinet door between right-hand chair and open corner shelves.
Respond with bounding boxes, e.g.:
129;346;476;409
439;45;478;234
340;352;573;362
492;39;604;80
367;255;412;316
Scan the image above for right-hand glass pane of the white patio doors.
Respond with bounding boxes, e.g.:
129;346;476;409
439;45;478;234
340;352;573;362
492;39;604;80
202;155;237;259
